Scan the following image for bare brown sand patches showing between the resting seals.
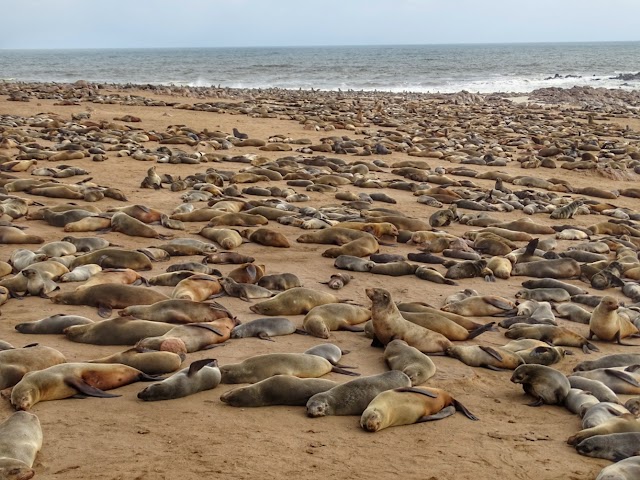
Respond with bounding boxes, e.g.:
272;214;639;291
0;86;638;480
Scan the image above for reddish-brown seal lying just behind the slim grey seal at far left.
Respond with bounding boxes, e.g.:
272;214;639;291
51;284;167;318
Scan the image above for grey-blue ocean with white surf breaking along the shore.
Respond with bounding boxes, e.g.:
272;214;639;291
0;42;640;93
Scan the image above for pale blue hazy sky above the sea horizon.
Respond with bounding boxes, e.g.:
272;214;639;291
0;0;640;49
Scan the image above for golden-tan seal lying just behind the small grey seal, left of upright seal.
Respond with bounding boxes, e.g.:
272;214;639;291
250;287;339;316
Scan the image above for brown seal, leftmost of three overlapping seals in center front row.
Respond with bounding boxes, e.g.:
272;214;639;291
220;375;336;407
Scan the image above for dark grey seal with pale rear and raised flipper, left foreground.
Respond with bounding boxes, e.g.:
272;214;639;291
138;358;222;402
